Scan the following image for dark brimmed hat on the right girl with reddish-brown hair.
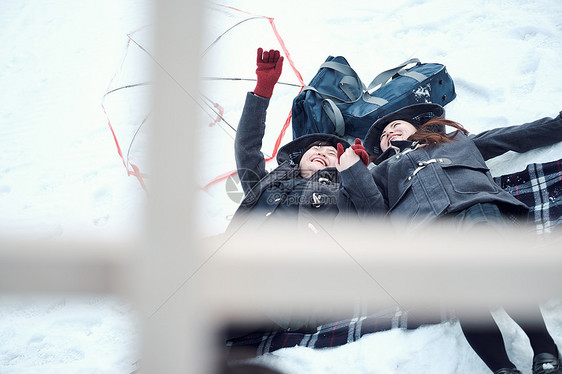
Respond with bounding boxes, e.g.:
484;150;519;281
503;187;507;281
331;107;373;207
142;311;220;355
363;103;445;156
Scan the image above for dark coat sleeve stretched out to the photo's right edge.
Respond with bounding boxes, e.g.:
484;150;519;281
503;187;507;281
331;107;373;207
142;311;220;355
470;109;562;160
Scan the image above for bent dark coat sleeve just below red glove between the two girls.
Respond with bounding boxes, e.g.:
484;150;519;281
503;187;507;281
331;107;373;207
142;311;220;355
338;161;387;217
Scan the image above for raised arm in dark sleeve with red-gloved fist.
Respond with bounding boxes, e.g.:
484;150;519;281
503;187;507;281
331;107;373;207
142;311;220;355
234;48;283;194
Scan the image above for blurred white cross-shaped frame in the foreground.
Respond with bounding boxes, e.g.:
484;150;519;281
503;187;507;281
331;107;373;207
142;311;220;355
0;0;562;373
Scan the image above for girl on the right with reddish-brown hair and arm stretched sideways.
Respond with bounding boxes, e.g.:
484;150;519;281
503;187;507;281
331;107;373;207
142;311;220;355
337;104;562;374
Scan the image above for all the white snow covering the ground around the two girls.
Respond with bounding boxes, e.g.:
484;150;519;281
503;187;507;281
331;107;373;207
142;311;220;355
0;0;562;373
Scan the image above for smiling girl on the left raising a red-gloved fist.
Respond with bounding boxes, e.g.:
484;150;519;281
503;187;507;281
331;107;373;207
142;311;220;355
228;48;356;232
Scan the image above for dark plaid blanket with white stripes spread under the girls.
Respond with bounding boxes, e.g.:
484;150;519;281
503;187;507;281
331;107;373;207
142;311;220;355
226;160;562;355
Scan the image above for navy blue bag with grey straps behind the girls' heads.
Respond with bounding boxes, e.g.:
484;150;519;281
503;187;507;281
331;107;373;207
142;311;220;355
292;56;456;139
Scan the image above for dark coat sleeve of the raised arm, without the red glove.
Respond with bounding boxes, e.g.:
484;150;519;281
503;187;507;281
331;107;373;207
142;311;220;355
234;92;269;195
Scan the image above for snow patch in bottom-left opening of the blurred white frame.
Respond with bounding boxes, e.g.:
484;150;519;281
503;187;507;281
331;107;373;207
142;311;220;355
0;296;138;373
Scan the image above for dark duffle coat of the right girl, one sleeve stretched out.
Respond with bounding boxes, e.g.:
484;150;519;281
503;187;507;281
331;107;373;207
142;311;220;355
341;109;562;221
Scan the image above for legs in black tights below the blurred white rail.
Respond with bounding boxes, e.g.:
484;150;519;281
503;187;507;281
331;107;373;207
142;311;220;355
459;307;558;372
